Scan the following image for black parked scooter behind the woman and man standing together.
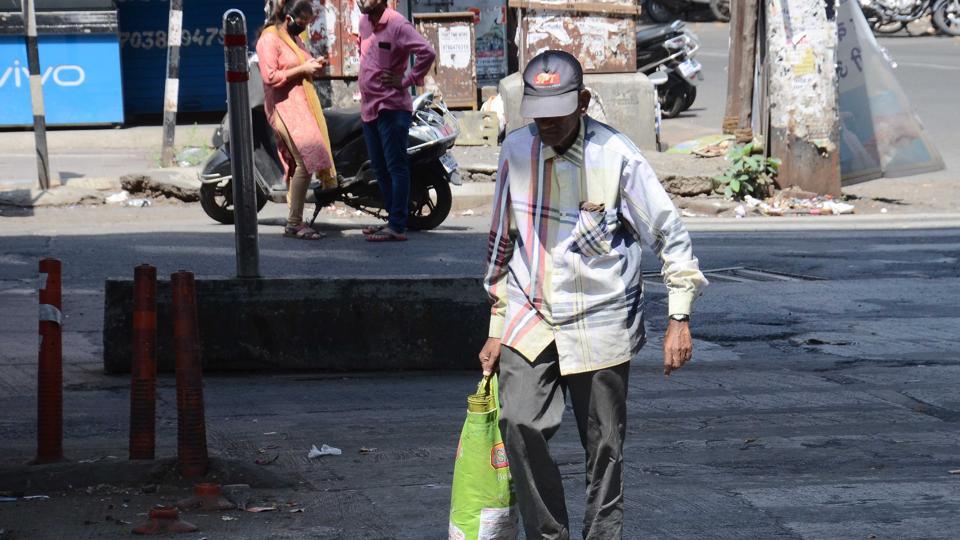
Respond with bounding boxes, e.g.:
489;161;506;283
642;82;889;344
200;55;460;230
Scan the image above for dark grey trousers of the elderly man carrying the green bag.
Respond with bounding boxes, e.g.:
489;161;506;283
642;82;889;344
500;346;630;540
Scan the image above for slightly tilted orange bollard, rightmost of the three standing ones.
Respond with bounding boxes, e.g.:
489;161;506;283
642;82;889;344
170;270;208;478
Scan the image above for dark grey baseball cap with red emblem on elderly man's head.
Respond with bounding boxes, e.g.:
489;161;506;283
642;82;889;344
520;50;583;118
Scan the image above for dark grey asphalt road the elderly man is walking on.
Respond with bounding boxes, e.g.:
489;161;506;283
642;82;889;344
0;210;960;540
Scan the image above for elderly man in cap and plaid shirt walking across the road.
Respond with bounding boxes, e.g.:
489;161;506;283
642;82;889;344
480;51;707;540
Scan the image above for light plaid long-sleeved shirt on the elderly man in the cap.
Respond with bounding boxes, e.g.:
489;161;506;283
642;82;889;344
484;117;707;375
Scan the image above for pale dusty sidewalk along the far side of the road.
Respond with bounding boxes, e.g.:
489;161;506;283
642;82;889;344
0;118;960;219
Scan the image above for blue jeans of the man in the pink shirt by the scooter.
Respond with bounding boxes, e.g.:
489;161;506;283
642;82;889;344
363;110;412;233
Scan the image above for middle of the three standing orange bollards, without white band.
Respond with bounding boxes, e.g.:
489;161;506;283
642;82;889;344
130;264;157;459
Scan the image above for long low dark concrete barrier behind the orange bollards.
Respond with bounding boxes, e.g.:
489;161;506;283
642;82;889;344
103;277;490;373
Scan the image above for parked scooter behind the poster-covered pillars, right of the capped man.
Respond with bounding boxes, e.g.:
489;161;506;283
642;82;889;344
637;21;703;118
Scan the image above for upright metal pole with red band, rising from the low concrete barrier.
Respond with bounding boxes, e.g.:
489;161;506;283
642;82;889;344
223;9;260;277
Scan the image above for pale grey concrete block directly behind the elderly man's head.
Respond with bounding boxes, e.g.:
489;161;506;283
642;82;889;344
500;73;657;150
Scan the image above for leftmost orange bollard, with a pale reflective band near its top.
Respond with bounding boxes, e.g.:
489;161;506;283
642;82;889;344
34;259;63;463
